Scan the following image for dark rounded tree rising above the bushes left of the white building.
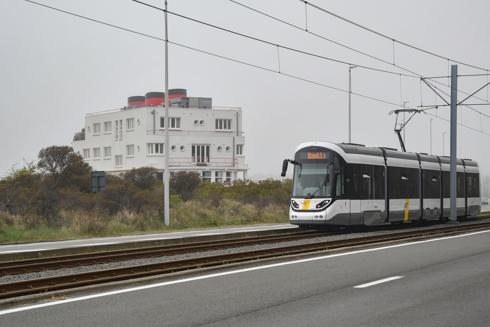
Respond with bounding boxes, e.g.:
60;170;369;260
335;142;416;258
37;146;91;191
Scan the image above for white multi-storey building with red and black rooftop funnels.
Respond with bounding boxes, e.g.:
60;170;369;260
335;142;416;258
72;89;248;182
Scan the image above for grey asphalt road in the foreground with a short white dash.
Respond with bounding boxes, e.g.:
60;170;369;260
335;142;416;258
0;231;490;327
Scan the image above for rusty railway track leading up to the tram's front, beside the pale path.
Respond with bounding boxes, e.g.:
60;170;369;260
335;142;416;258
0;231;326;276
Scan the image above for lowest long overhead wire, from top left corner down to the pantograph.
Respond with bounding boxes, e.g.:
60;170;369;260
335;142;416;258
25;0;490;135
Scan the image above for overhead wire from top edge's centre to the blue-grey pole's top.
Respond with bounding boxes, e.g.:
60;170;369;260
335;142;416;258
228;0;489;109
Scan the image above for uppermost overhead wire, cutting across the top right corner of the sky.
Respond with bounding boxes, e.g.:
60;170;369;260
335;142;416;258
298;0;488;72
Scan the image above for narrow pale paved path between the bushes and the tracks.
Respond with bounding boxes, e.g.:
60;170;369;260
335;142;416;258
0;224;295;255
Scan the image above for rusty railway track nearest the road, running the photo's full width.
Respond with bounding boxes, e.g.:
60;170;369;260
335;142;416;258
0;222;490;299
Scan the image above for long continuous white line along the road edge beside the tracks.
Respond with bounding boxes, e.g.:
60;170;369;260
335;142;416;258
0;230;490;316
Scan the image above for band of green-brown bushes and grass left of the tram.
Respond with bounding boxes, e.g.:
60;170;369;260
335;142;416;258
0;146;291;242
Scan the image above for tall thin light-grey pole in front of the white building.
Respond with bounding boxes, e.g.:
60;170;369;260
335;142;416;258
163;0;170;226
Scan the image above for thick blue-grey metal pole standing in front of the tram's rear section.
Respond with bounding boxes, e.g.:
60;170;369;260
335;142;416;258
449;65;458;222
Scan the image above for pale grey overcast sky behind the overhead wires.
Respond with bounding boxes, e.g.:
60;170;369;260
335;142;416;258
0;0;490;188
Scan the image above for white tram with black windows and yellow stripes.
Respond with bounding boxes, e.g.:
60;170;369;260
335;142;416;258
281;142;481;226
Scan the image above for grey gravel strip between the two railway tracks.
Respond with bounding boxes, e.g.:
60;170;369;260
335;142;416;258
0;220;488;285
